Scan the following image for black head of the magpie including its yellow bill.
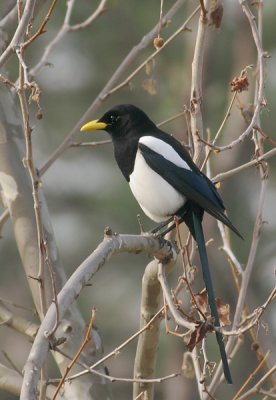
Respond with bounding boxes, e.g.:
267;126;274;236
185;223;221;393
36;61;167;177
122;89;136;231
81;104;155;141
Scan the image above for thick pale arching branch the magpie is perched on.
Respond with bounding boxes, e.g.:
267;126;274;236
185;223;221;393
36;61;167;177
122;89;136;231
21;230;173;400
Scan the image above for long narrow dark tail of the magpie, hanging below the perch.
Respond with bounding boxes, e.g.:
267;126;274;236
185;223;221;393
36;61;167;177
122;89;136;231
192;211;233;383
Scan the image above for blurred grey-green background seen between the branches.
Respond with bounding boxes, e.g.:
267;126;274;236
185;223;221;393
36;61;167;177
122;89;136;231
0;0;276;400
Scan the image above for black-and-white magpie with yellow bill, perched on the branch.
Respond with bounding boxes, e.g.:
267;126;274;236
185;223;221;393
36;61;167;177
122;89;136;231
81;104;242;383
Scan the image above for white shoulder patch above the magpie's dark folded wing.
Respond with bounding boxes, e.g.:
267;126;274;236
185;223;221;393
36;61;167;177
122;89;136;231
139;136;191;170
